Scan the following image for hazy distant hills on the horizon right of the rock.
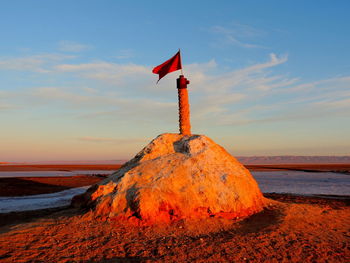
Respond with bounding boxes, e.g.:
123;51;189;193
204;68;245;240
237;155;350;164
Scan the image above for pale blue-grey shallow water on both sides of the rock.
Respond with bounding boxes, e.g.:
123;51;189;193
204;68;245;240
0;170;350;213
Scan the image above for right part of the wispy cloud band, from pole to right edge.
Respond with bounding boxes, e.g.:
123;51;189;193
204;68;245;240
185;54;350;126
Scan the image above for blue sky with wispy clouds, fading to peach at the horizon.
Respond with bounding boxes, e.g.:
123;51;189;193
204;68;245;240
0;0;350;161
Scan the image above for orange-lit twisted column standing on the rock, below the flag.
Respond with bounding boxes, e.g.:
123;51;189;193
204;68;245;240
176;75;191;135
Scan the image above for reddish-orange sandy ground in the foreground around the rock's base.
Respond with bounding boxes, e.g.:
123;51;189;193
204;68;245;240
0;164;350;262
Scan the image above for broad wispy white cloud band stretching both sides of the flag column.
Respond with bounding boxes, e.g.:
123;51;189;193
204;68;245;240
0;53;350;132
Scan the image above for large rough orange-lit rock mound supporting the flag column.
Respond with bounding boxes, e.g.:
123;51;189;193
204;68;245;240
73;134;265;222
